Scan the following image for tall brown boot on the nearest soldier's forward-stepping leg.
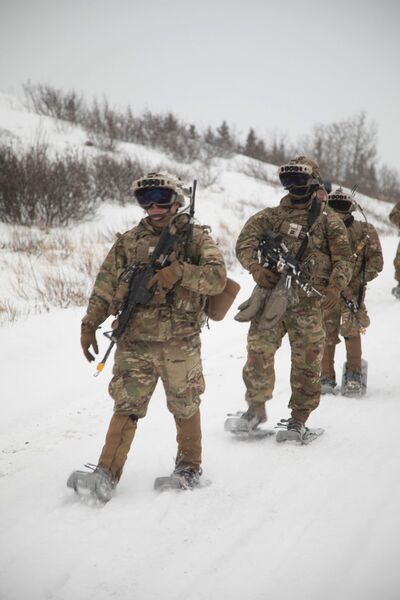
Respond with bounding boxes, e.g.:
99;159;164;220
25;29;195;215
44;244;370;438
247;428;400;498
98;414;137;483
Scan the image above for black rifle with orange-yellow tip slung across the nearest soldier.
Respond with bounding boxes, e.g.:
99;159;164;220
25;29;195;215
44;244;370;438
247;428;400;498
95;214;187;376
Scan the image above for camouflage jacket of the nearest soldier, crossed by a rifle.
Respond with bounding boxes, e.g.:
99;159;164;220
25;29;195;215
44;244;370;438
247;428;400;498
83;218;226;341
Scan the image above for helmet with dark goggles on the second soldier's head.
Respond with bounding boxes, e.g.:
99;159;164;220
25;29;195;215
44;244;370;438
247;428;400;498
278;156;321;200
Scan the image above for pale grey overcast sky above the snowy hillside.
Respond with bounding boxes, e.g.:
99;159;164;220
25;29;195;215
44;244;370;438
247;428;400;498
0;0;400;169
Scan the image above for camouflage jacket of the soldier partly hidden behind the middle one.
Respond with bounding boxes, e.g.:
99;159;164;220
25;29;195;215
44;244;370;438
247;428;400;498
347;221;383;285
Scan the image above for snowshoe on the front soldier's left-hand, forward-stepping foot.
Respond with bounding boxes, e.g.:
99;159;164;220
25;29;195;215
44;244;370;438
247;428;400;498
67;465;116;504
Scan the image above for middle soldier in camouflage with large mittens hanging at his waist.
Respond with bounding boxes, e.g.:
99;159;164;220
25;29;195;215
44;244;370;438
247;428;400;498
236;156;351;439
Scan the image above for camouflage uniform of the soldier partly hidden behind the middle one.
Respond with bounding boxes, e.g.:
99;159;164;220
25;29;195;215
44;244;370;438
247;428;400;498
322;215;383;381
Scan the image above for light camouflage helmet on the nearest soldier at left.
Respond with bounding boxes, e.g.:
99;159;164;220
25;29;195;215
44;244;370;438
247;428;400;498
132;171;190;208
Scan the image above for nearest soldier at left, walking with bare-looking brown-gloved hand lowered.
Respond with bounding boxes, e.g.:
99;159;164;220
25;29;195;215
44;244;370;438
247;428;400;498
68;172;226;502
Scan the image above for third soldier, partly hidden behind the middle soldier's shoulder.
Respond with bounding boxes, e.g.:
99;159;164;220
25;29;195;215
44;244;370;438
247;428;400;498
321;188;383;395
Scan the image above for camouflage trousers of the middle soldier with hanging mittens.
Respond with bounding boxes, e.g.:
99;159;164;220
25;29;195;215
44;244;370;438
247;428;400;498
243;298;325;414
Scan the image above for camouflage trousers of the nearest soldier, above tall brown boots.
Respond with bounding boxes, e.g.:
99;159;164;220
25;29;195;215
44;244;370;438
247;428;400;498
109;334;205;419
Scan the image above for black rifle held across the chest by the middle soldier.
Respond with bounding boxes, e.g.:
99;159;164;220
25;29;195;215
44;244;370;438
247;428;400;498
259;229;322;297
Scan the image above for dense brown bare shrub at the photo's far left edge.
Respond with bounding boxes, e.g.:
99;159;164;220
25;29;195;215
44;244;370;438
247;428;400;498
0;145;96;228
